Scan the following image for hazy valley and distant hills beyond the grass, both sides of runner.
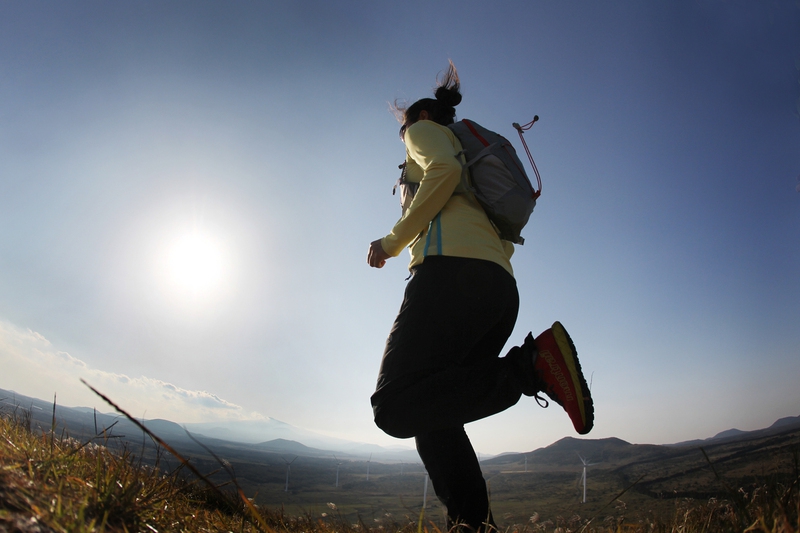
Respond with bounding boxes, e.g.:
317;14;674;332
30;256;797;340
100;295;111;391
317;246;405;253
1;386;800;524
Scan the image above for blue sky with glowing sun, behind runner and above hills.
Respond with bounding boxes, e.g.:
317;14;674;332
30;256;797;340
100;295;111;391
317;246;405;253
0;0;800;453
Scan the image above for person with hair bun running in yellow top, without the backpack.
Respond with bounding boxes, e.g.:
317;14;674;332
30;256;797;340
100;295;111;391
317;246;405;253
367;62;594;532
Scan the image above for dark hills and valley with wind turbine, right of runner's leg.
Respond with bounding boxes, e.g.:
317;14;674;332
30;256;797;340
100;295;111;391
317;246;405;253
483;423;800;516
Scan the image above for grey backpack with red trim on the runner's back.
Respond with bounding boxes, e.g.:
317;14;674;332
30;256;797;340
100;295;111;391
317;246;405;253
448;116;542;244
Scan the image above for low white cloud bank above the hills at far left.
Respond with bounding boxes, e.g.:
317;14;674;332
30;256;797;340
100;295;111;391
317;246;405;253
0;320;265;422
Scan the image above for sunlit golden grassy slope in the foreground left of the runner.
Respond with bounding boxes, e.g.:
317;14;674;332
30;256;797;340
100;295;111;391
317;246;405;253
0;404;436;533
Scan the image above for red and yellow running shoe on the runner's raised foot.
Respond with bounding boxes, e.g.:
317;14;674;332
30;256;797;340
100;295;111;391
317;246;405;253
534;322;594;435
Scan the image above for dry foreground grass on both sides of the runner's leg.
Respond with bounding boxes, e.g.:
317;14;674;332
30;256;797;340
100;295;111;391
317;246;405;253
0;402;800;533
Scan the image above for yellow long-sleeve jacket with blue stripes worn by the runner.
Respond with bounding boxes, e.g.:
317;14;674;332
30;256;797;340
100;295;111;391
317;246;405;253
381;120;514;276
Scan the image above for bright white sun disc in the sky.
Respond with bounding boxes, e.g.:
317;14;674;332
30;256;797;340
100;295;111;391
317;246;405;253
167;233;224;294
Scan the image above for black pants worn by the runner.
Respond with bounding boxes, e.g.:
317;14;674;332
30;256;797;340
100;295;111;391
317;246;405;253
372;256;522;530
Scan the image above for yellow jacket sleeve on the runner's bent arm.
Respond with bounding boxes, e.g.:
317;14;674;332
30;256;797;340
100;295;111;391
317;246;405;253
381;120;461;257
